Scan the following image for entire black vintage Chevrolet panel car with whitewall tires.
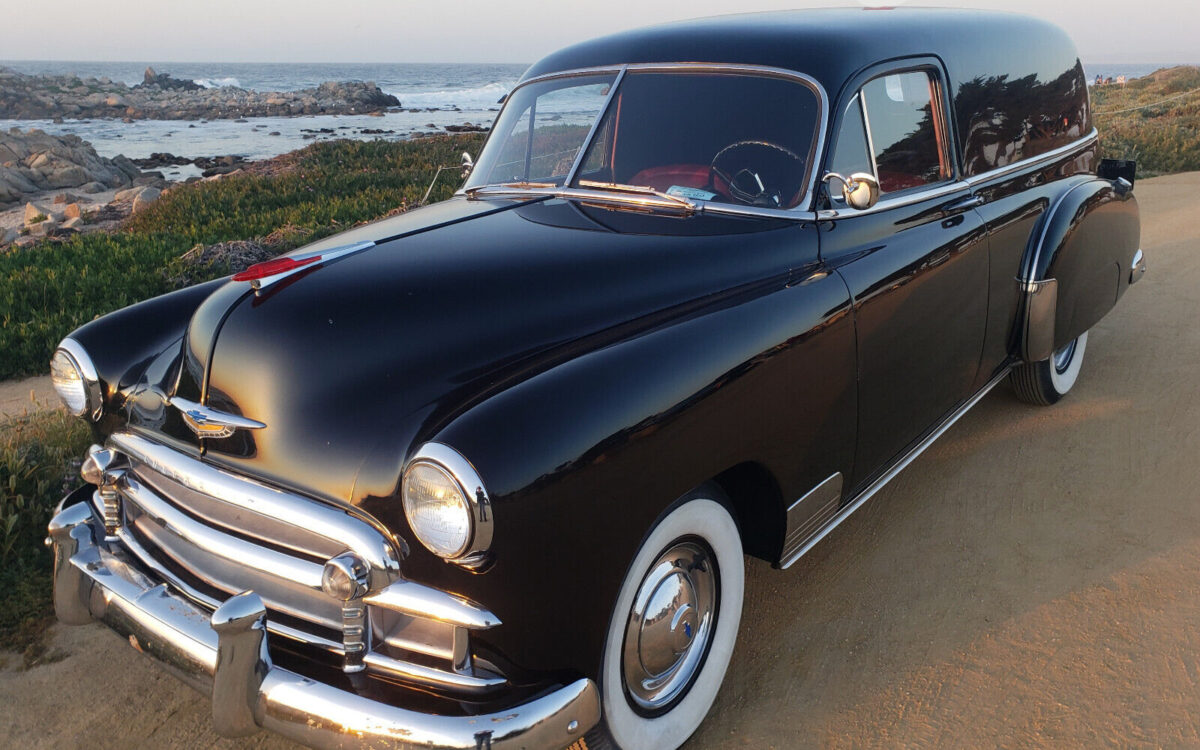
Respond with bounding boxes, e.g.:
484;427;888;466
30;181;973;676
49;10;1145;749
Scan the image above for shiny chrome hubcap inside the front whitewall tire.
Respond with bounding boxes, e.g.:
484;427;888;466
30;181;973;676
622;541;719;712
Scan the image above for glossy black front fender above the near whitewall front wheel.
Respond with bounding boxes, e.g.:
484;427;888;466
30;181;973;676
422;266;857;677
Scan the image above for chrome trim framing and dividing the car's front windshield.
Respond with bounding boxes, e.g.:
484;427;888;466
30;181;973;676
455;62;829;221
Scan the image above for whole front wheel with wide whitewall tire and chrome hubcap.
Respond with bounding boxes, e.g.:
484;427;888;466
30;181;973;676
590;485;745;750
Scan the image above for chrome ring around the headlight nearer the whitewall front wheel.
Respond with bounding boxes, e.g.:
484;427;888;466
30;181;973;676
401;443;494;568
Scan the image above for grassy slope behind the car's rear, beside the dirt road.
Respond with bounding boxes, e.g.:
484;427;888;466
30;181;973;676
1092;66;1200;178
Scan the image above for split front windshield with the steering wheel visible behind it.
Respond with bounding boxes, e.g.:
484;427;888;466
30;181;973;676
467;70;821;209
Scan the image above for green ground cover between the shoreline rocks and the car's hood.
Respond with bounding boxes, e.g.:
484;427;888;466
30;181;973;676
0;134;482;380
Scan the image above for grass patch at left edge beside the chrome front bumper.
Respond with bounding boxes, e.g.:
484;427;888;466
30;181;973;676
0;409;91;666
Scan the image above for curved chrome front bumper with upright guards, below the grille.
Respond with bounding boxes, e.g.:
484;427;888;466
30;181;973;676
47;498;600;750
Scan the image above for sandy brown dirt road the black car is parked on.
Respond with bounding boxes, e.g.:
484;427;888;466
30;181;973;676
0;174;1200;750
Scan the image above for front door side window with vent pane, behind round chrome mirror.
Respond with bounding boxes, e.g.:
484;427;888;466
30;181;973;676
830;71;950;203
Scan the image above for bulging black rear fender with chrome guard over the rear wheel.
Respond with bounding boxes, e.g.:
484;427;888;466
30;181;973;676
1016;175;1141;362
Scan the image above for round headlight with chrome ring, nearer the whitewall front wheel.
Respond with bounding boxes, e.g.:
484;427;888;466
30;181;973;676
401;443;492;568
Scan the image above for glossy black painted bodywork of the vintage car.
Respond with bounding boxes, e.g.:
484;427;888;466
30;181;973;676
68;8;1135;696
